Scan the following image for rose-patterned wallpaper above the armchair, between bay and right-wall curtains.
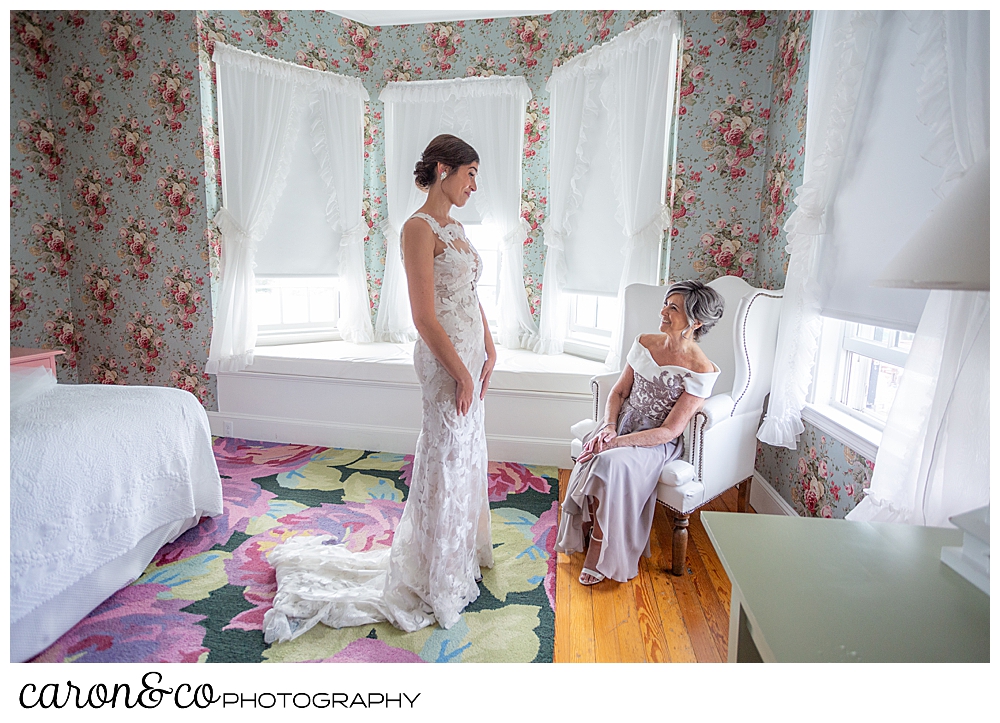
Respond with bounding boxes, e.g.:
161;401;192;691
670;10;811;288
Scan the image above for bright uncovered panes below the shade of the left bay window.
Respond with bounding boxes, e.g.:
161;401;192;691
254;276;340;346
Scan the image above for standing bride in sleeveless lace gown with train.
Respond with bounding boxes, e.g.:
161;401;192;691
264;135;496;643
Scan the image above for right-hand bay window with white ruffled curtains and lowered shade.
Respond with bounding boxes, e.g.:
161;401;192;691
540;12;681;360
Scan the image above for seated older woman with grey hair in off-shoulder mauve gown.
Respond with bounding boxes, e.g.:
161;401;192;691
556;281;724;585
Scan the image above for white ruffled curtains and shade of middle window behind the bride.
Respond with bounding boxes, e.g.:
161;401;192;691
375;76;537;348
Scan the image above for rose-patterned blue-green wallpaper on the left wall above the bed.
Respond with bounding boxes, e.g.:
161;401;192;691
10;10;215;402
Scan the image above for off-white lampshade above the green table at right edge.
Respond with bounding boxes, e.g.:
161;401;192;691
872;154;990;291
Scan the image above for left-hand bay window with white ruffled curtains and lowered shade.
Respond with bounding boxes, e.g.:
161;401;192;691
206;43;373;374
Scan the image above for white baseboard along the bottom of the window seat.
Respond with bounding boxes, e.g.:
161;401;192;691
208;412;573;469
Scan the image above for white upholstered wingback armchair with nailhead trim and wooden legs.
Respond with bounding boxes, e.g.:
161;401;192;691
572;276;781;575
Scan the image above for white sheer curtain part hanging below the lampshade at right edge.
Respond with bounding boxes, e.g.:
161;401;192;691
847;291;990;527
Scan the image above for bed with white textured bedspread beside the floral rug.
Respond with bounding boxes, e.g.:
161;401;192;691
10;369;222;662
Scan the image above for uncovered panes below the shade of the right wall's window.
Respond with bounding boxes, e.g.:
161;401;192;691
804;317;913;444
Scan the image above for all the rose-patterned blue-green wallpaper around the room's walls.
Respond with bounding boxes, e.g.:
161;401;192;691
10;10;868;514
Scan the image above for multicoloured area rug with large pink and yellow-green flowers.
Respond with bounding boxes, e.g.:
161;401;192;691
34;437;558;663
